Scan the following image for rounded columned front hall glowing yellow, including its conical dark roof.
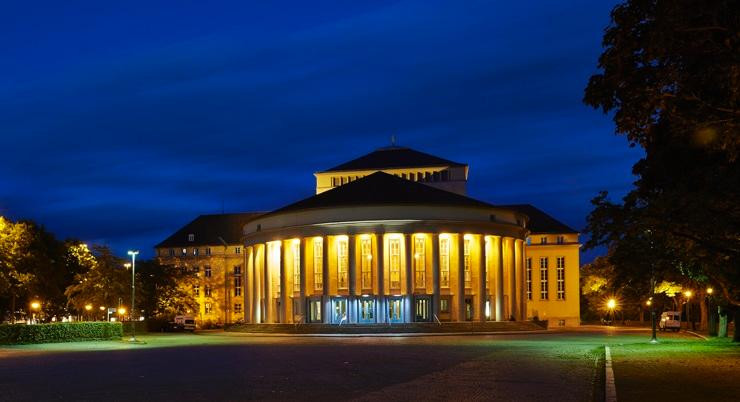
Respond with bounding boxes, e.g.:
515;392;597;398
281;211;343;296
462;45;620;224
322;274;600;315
237;173;578;325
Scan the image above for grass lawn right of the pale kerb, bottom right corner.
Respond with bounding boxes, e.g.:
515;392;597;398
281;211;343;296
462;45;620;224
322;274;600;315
611;337;740;402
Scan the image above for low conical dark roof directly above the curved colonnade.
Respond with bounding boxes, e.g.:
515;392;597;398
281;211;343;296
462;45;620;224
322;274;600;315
271;172;494;214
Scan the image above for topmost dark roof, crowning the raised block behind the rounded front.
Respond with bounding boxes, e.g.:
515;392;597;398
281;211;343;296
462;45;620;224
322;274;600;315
324;146;465;172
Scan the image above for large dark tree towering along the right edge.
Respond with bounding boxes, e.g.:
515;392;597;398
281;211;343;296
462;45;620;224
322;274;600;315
584;0;740;340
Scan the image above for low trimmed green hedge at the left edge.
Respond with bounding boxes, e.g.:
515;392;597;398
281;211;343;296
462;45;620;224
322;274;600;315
0;322;123;344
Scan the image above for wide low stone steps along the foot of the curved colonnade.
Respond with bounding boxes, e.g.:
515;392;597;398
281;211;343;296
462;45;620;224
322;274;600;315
224;321;547;334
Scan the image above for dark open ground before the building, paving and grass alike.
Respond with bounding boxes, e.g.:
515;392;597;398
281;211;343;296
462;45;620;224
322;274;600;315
0;328;740;401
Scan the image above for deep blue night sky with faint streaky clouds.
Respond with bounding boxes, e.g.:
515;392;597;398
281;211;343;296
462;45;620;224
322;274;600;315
0;0;640;261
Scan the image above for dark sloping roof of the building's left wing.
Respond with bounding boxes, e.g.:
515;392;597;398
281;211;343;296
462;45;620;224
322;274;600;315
154;212;263;248
